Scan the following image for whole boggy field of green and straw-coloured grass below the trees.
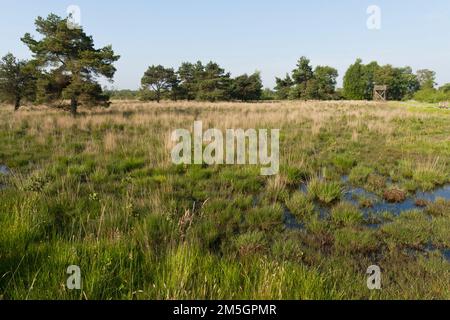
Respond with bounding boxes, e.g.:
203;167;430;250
0;101;450;299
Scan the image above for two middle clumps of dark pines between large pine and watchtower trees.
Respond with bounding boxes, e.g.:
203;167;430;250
140;57;339;102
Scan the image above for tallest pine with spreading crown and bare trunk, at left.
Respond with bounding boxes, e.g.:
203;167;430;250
22;14;120;115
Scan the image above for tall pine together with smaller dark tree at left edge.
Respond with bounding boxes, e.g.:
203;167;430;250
0;14;120;115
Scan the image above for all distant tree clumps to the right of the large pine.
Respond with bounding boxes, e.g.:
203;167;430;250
140;57;450;102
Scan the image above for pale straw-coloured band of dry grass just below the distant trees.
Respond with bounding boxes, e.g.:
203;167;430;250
1;101;418;133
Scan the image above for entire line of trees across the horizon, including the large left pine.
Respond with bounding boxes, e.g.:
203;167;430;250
0;14;450;115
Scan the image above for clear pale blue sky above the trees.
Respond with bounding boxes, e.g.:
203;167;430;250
0;0;450;89
